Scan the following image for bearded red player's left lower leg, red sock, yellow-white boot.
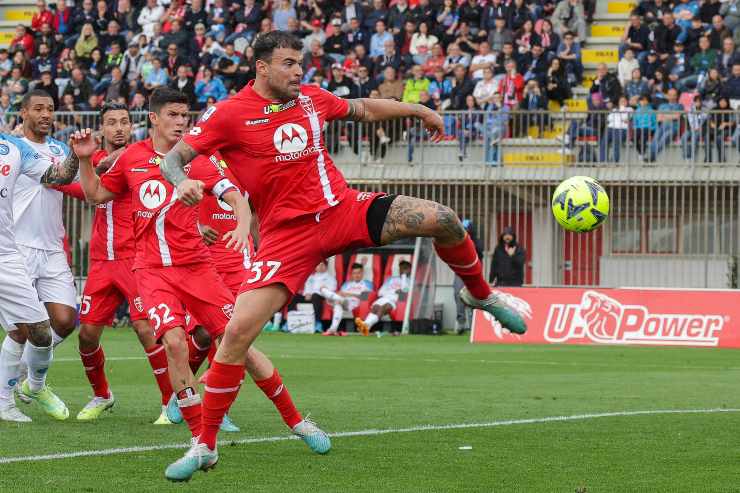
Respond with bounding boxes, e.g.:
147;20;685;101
77;323;115;421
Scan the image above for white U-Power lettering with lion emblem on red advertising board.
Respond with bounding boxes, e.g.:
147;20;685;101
544;290;728;346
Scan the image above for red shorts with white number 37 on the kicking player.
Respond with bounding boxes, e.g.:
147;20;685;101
239;190;386;294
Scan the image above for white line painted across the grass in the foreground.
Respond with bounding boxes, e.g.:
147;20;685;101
0;408;740;464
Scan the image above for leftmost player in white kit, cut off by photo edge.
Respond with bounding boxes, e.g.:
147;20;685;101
0;129;79;422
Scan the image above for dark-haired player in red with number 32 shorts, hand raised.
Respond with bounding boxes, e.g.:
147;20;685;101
70;88;251;446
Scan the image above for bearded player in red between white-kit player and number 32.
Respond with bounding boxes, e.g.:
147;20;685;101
57;103;172;424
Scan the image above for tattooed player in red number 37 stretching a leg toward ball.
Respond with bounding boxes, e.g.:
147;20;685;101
160;31;526;480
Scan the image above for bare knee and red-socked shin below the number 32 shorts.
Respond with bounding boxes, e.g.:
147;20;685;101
162;327;201;438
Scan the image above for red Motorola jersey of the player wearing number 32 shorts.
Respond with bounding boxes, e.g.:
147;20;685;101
100;139;236;269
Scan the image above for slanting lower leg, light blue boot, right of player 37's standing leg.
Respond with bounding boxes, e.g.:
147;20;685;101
246;346;331;454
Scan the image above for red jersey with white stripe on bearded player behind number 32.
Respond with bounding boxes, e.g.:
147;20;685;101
55;149;135;260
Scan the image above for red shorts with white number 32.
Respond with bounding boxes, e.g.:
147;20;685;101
135;263;234;340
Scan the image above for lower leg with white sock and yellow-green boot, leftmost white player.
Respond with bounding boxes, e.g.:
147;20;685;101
15;320;69;420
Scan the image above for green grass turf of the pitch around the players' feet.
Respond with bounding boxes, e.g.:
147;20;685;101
0;330;740;493
